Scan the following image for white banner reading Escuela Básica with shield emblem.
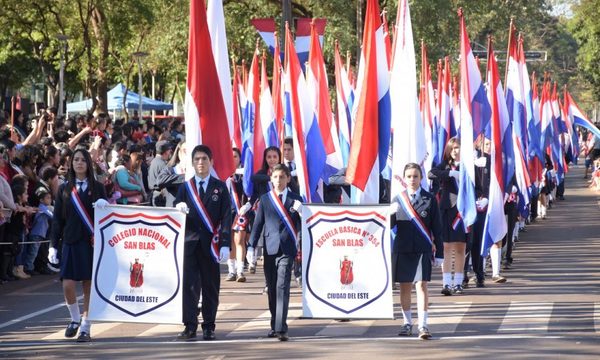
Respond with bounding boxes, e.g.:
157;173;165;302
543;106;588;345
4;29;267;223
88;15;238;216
302;204;394;319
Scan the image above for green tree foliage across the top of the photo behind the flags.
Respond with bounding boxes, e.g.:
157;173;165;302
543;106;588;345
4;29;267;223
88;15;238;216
0;0;600;114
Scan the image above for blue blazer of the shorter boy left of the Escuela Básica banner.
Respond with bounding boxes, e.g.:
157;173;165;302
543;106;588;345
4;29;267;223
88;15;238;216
250;189;302;256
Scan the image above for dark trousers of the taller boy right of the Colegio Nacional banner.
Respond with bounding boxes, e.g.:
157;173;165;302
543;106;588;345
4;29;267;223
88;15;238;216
182;241;221;330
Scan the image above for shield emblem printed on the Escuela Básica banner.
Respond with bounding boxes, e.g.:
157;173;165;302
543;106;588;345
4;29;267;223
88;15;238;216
303;210;391;314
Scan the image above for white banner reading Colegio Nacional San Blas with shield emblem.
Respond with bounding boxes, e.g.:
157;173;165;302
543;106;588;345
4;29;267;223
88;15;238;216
89;205;185;324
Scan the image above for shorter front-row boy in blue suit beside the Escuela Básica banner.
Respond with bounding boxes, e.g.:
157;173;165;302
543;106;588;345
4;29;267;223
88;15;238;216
248;164;302;341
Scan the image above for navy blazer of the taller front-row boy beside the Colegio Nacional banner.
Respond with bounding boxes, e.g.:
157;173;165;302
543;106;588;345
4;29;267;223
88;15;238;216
175;176;231;255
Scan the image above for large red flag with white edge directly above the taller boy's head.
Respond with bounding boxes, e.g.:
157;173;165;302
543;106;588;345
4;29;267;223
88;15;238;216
185;0;235;179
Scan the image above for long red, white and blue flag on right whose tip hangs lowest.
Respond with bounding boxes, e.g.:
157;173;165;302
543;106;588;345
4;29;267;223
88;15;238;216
482;39;510;255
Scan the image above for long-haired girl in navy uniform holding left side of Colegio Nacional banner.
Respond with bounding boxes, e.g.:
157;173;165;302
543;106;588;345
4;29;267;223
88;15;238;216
48;148;107;342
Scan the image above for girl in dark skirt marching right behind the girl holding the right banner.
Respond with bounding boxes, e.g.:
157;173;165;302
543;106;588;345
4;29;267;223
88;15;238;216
429;138;467;296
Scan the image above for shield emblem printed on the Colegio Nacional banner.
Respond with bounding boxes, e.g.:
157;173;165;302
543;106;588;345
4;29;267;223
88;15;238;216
93;213;183;317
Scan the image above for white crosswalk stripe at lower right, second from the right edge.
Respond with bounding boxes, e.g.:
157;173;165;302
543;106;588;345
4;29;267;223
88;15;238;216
498;301;554;332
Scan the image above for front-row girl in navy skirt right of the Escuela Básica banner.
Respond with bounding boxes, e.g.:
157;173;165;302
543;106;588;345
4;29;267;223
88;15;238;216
390;163;443;340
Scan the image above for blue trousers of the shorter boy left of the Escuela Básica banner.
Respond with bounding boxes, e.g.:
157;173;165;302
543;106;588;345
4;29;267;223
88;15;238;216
264;250;294;332
